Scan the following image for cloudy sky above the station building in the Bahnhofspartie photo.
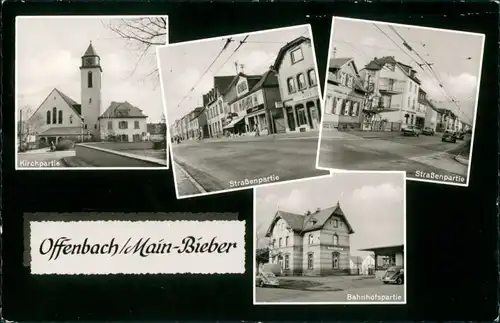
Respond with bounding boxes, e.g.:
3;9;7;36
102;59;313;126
255;173;405;256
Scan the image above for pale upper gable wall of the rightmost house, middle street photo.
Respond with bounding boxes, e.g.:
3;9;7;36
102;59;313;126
278;41;318;101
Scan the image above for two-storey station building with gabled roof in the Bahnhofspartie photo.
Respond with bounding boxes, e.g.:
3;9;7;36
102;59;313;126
266;203;354;275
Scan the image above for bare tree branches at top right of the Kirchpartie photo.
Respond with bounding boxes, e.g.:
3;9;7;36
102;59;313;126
106;17;167;84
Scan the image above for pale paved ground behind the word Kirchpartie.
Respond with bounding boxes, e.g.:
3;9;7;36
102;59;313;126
17;148;75;168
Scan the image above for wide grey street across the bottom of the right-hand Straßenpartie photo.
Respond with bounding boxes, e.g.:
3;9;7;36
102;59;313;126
318;131;469;184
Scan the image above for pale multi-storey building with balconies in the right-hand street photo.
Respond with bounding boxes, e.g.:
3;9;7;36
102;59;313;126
360;56;421;130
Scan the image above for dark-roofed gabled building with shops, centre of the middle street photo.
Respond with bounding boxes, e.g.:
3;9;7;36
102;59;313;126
223;70;285;134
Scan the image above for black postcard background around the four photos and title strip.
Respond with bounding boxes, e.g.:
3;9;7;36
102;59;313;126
2;2;499;321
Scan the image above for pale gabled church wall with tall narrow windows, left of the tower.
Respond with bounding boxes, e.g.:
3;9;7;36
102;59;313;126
28;90;82;133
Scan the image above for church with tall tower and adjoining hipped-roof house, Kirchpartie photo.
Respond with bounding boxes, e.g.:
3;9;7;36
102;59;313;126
28;42;147;146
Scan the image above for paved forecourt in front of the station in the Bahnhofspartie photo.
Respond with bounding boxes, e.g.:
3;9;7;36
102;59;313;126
255;276;405;303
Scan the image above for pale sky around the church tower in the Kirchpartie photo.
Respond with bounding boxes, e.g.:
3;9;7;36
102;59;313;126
16;17;166;122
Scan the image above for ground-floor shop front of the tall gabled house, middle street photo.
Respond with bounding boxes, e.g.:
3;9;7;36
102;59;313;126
283;87;321;132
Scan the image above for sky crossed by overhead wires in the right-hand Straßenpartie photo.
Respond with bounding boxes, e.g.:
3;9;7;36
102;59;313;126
330;18;484;122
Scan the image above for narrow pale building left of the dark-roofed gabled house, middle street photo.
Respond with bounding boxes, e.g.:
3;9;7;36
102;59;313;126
203;75;234;138
